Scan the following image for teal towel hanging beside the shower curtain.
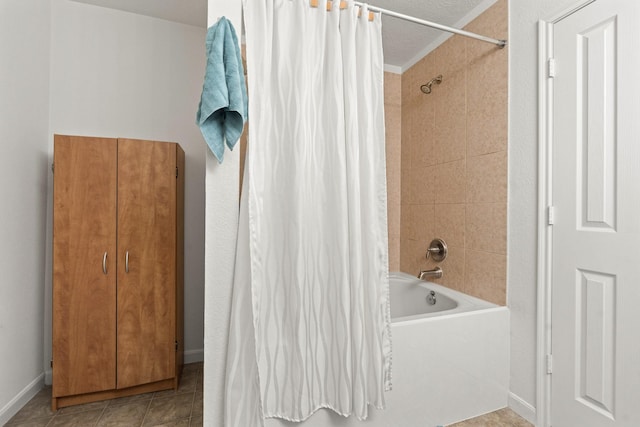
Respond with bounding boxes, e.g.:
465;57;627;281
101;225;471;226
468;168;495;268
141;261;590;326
196;17;249;163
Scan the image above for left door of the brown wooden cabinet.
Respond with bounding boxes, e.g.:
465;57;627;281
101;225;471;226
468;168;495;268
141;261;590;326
53;135;117;396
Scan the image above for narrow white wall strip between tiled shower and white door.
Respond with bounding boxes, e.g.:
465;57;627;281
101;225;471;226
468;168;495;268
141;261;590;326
507;0;578;421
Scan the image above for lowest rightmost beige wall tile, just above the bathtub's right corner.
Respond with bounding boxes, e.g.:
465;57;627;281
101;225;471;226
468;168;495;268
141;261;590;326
464;250;507;305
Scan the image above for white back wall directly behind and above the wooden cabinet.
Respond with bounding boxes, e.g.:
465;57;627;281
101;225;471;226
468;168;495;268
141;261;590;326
45;0;207;382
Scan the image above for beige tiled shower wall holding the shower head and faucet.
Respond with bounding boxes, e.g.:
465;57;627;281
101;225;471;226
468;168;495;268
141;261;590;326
398;0;508;305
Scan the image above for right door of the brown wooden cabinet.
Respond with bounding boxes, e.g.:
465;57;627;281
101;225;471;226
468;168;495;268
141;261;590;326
117;139;176;388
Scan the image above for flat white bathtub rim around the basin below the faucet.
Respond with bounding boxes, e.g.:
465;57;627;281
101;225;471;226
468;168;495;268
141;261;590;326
389;271;505;324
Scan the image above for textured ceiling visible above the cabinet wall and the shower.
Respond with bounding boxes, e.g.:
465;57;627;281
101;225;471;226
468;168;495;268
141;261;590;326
75;0;496;73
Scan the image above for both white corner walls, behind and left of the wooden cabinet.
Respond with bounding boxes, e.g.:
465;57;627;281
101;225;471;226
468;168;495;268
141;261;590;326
0;0;207;425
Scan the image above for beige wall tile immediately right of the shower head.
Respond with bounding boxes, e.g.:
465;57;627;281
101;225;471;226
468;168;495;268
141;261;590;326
428;70;467;163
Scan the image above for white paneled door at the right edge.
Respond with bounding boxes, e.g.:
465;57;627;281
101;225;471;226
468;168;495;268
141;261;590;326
551;0;640;427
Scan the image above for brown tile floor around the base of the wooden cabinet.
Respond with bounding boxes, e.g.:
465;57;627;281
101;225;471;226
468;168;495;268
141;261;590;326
5;363;202;427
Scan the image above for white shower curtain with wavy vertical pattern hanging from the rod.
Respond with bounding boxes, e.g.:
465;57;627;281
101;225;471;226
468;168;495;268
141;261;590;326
225;0;391;427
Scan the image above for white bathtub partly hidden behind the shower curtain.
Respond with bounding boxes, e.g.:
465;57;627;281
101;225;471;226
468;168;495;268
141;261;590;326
265;273;509;427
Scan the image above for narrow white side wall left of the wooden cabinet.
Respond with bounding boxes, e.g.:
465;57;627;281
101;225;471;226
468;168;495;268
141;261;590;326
0;0;51;425
